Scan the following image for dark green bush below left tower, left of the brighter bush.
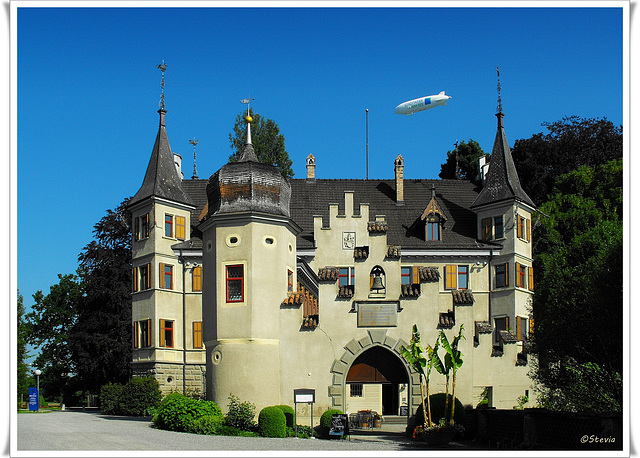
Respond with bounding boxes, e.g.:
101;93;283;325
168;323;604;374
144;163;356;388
100;376;162;417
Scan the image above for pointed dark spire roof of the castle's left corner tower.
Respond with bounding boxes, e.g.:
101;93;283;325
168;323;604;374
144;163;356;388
129;109;193;206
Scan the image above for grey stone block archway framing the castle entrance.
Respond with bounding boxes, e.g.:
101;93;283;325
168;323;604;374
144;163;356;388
329;329;421;415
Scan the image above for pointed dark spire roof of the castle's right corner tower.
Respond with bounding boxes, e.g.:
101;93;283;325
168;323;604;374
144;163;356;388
471;112;535;208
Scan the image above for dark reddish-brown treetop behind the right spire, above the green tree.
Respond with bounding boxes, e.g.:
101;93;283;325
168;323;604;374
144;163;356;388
511;116;622;205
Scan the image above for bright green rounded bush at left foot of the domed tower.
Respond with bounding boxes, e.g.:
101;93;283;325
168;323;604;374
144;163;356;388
153;393;224;433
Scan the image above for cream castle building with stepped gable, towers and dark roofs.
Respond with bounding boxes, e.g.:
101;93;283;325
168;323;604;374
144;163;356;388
129;102;536;419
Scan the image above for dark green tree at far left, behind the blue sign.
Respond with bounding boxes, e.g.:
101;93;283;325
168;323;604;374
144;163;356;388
25;274;83;398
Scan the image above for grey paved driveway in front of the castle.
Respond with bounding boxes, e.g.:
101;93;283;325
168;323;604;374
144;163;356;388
17;411;456;452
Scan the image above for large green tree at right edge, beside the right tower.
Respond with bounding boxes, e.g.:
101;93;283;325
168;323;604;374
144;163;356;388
531;159;623;412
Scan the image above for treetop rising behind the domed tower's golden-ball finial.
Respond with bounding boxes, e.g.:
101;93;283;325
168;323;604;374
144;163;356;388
229;109;294;178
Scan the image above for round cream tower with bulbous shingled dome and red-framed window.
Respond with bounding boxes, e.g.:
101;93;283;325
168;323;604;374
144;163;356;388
199;116;300;409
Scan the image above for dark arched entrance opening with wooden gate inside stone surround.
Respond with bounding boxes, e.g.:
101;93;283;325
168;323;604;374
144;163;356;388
345;345;409;415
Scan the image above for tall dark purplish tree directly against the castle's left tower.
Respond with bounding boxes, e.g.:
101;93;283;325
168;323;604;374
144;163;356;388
69;199;131;393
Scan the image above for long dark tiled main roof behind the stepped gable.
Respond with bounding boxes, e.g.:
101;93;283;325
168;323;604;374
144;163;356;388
182;178;492;250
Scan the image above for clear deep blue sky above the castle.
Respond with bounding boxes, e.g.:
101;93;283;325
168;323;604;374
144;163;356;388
11;2;625;318
